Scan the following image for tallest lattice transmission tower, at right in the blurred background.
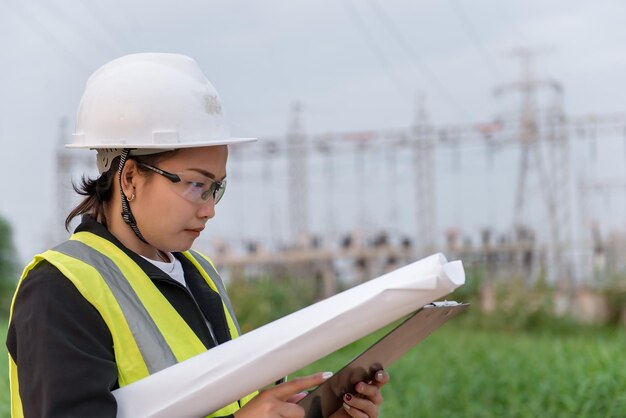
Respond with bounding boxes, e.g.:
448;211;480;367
496;48;574;283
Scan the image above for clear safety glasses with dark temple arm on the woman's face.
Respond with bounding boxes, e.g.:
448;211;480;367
137;161;226;205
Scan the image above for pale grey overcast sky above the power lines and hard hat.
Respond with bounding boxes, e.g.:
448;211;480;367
0;0;626;260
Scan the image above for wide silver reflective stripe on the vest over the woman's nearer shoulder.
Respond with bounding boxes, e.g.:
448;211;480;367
53;240;178;374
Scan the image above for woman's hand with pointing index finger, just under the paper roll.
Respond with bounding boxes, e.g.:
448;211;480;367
235;372;332;418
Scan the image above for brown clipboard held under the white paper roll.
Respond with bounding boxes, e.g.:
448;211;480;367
298;301;469;418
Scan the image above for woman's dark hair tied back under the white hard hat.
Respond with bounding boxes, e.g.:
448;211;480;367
65;151;176;232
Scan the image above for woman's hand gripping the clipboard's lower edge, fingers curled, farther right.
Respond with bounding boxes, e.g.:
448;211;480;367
330;370;389;418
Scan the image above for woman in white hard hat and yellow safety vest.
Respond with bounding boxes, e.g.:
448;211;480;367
7;54;389;418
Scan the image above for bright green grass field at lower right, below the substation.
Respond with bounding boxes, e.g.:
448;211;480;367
0;321;626;418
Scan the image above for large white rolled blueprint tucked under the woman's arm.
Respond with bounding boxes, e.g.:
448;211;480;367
113;254;465;418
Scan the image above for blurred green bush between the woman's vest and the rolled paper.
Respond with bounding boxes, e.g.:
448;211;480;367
228;277;317;332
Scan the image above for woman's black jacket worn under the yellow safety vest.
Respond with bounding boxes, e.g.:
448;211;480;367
7;216;232;418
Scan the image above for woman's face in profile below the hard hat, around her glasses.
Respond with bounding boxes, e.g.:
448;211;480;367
130;145;228;252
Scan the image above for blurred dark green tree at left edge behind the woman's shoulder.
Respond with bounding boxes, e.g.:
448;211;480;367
0;217;18;316
